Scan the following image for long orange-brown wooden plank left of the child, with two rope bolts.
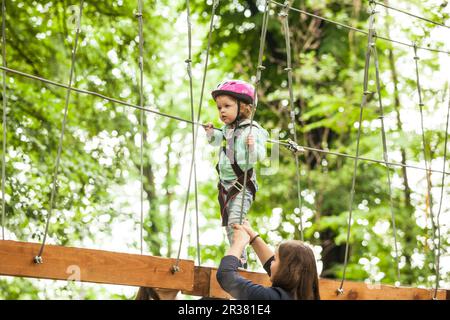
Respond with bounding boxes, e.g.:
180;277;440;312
0;240;194;290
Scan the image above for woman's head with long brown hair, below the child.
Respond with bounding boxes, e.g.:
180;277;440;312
272;240;320;300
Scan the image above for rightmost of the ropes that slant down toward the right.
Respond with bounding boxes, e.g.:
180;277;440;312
413;43;436;278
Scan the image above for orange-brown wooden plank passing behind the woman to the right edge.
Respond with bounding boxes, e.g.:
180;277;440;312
210;268;450;300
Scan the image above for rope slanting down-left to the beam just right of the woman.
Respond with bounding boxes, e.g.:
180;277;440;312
337;8;375;294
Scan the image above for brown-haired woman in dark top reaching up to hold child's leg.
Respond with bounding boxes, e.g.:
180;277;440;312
217;222;320;300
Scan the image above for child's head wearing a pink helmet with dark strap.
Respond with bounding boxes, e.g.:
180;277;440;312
211;80;255;124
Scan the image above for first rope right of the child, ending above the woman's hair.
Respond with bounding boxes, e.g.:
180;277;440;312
280;1;304;241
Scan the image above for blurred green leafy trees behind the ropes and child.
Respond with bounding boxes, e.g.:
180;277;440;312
0;0;450;299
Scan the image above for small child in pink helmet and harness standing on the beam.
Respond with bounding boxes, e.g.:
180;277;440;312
205;80;269;268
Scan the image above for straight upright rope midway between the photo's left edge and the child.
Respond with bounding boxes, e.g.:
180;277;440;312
136;0;144;254
